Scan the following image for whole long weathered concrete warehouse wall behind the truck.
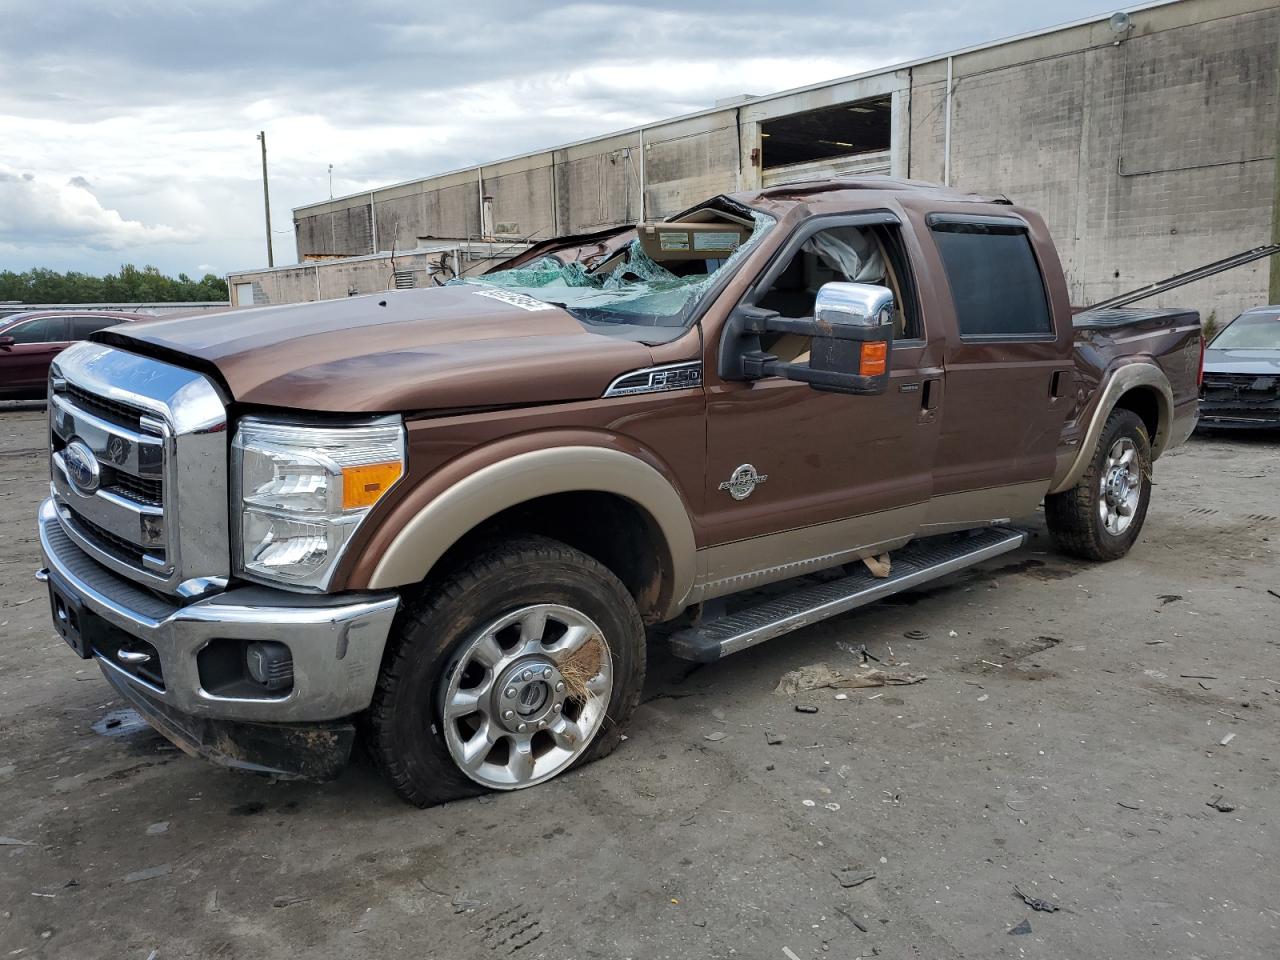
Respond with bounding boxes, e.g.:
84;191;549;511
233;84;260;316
285;0;1280;321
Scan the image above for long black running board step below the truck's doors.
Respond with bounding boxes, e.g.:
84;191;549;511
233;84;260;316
671;527;1027;663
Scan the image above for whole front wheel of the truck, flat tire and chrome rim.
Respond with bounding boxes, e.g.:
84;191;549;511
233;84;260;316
369;538;645;806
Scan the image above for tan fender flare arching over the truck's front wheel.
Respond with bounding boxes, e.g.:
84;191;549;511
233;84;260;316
367;445;696;616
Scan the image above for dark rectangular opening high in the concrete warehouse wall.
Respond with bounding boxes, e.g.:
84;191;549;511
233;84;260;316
760;96;893;170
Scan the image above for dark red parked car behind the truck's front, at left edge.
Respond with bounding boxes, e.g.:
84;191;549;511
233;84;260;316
0;311;147;399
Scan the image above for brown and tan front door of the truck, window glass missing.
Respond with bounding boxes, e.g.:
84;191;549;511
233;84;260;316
699;214;943;598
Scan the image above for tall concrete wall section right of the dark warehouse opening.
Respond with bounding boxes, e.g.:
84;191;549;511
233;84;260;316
911;0;1280;323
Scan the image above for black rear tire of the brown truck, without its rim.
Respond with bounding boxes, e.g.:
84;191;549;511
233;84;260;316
1044;410;1151;561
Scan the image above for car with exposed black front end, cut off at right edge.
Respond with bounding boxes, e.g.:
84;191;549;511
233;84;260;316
1201;305;1280;428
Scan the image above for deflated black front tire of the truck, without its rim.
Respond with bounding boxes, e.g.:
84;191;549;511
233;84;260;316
365;536;645;806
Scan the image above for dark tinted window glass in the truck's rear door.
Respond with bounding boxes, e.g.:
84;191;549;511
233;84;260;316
933;223;1053;340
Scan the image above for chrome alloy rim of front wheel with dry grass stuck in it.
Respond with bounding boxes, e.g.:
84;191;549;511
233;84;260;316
440;603;613;790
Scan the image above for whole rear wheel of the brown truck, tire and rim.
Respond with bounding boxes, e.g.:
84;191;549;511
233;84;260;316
1044;410;1151;561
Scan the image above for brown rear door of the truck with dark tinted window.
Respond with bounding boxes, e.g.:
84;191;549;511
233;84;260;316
925;214;1074;532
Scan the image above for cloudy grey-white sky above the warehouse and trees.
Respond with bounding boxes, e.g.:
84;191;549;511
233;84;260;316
0;0;1095;275
